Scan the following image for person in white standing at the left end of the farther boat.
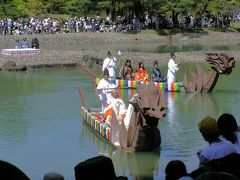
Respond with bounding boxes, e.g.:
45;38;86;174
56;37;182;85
102;51;117;79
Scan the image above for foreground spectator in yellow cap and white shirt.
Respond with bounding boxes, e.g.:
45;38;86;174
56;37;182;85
198;116;236;167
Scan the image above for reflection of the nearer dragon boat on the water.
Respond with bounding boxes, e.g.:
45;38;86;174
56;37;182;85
82;122;160;180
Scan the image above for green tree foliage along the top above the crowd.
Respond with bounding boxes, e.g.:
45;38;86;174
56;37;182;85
0;0;240;19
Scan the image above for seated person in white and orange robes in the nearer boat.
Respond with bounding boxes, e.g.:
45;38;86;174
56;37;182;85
103;88;127;126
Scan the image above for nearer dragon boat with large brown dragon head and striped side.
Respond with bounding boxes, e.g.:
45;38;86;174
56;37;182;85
80;83;166;152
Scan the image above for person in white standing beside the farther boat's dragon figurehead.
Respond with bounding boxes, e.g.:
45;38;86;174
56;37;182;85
167;52;179;85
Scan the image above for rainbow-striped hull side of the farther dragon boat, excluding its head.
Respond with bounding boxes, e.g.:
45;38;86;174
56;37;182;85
95;78;182;92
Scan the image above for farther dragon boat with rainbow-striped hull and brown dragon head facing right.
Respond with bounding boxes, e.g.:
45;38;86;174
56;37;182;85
95;53;235;93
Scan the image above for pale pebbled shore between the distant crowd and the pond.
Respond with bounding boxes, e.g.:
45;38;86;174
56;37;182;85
0;32;240;70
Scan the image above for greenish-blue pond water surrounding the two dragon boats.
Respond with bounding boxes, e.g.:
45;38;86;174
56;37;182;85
0;62;240;180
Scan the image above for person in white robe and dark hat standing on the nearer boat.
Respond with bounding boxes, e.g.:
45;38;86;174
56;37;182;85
97;69;115;113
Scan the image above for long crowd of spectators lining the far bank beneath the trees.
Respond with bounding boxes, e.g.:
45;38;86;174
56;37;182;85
0;13;240;35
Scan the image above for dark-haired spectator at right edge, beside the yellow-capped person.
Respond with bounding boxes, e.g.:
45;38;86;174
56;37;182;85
217;113;240;154
